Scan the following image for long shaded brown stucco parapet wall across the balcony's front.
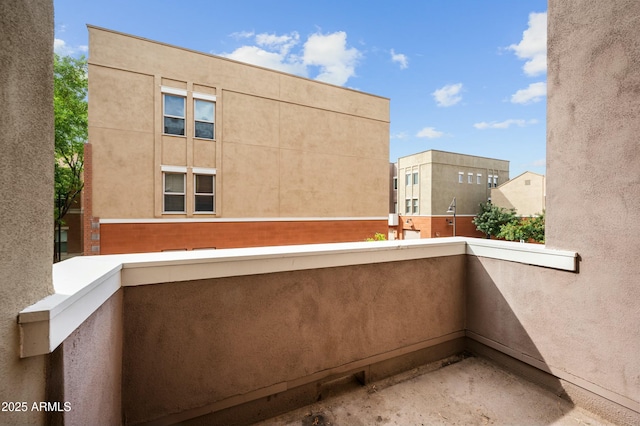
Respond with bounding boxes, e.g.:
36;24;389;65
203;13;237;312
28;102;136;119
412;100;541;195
123;256;465;423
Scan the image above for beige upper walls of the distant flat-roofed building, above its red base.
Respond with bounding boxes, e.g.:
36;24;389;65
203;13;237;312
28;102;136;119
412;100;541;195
398;150;509;216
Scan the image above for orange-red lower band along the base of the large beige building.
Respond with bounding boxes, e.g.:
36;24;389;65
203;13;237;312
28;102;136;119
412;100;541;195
94;219;387;254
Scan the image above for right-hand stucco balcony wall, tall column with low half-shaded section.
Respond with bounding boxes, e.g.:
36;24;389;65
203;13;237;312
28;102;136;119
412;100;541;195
468;0;640;420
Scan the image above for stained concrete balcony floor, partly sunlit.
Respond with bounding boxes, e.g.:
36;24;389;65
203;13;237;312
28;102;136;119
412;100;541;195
257;357;612;426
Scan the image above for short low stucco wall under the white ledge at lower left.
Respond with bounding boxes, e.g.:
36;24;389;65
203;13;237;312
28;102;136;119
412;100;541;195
47;291;123;426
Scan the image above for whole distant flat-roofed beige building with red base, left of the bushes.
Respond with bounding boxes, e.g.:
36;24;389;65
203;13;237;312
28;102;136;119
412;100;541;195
397;150;509;239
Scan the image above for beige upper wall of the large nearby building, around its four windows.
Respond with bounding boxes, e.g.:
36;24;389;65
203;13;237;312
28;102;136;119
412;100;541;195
89;26;389;219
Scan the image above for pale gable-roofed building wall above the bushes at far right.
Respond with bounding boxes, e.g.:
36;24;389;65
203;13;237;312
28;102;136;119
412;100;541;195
491;172;546;217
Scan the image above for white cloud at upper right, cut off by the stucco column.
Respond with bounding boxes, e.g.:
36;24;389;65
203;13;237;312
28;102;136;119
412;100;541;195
508;12;547;76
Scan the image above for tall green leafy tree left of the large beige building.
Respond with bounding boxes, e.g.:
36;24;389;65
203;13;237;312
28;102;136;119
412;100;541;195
53;54;88;256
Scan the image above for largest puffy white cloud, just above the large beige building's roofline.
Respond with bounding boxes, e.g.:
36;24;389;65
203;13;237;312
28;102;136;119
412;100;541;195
221;31;362;86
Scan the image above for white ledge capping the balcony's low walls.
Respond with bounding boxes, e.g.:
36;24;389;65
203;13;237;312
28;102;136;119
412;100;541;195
18;237;577;358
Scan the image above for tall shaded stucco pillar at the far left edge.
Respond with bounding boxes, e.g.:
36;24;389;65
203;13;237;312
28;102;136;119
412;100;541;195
0;0;53;424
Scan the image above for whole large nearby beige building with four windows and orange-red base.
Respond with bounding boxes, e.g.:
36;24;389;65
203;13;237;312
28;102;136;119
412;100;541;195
85;26;389;254
